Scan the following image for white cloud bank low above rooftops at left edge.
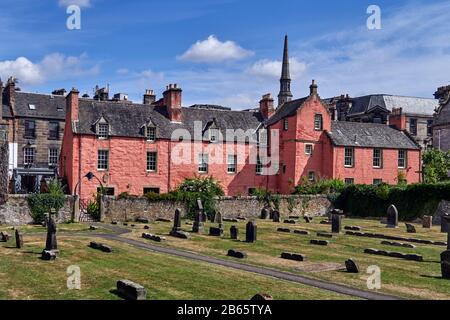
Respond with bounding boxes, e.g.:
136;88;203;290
0;53;99;85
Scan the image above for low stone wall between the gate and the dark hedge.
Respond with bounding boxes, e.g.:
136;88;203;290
102;196;332;222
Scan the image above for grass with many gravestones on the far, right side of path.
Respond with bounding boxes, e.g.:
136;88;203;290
124;218;450;299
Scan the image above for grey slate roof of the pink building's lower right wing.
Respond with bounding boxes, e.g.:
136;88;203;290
328;121;420;150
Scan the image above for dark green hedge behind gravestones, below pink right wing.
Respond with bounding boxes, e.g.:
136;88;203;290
334;183;450;221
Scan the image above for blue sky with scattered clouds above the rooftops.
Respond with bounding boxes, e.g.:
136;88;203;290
0;0;450;109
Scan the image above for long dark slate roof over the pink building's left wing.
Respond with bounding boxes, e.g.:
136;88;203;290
76;99;263;139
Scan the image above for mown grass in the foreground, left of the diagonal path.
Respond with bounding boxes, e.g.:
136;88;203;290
0;232;349;300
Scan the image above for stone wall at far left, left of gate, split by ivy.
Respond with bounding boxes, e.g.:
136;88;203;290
0;195;73;226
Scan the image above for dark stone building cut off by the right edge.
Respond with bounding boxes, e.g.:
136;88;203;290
433;86;450;151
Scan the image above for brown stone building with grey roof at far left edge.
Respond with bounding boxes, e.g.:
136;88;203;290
2;78;66;193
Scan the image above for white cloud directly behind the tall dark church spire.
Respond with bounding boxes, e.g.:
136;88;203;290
247;58;306;79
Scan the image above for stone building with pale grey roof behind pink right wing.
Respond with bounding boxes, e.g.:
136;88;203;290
326;94;439;150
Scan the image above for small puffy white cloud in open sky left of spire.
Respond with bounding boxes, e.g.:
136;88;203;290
177;35;253;63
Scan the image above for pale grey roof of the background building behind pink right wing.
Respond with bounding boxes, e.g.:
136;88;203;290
349;94;439;116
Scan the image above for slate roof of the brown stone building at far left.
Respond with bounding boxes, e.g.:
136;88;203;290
15;91;66;121
